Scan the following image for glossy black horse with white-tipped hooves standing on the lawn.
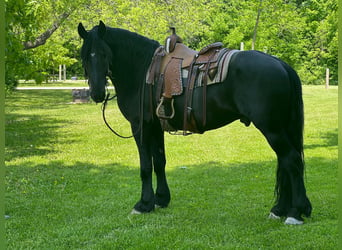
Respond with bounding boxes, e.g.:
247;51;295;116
78;21;312;224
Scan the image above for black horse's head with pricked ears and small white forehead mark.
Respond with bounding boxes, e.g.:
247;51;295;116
78;21;112;103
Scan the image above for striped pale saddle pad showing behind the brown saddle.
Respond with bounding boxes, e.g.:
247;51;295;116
195;50;239;87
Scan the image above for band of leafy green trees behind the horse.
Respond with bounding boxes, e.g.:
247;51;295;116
5;0;337;89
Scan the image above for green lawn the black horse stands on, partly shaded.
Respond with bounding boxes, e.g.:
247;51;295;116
5;86;338;249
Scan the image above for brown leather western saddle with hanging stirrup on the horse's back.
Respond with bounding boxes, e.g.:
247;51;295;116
146;27;236;134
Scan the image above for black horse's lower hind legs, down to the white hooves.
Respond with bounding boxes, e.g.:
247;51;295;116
263;131;311;224
